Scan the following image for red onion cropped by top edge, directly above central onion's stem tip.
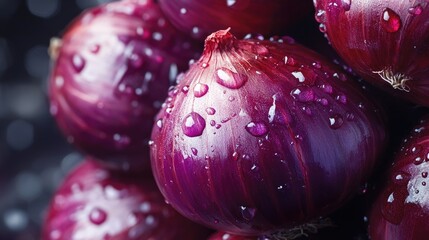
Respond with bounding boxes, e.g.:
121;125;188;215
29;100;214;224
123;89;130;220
159;0;312;40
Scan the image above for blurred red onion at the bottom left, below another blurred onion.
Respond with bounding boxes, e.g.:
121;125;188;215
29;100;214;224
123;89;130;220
42;160;208;240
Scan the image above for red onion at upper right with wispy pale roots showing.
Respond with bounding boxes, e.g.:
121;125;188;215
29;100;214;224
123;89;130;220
314;0;429;106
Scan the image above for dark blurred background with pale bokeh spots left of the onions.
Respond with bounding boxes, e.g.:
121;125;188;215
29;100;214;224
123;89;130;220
0;0;115;240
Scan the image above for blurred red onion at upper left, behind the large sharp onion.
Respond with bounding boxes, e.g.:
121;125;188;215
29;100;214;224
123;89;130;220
49;0;203;170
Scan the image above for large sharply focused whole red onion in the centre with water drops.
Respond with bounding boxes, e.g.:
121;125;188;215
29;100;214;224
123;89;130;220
151;30;386;235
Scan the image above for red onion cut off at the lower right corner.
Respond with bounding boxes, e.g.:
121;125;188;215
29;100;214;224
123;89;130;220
369;116;429;240
